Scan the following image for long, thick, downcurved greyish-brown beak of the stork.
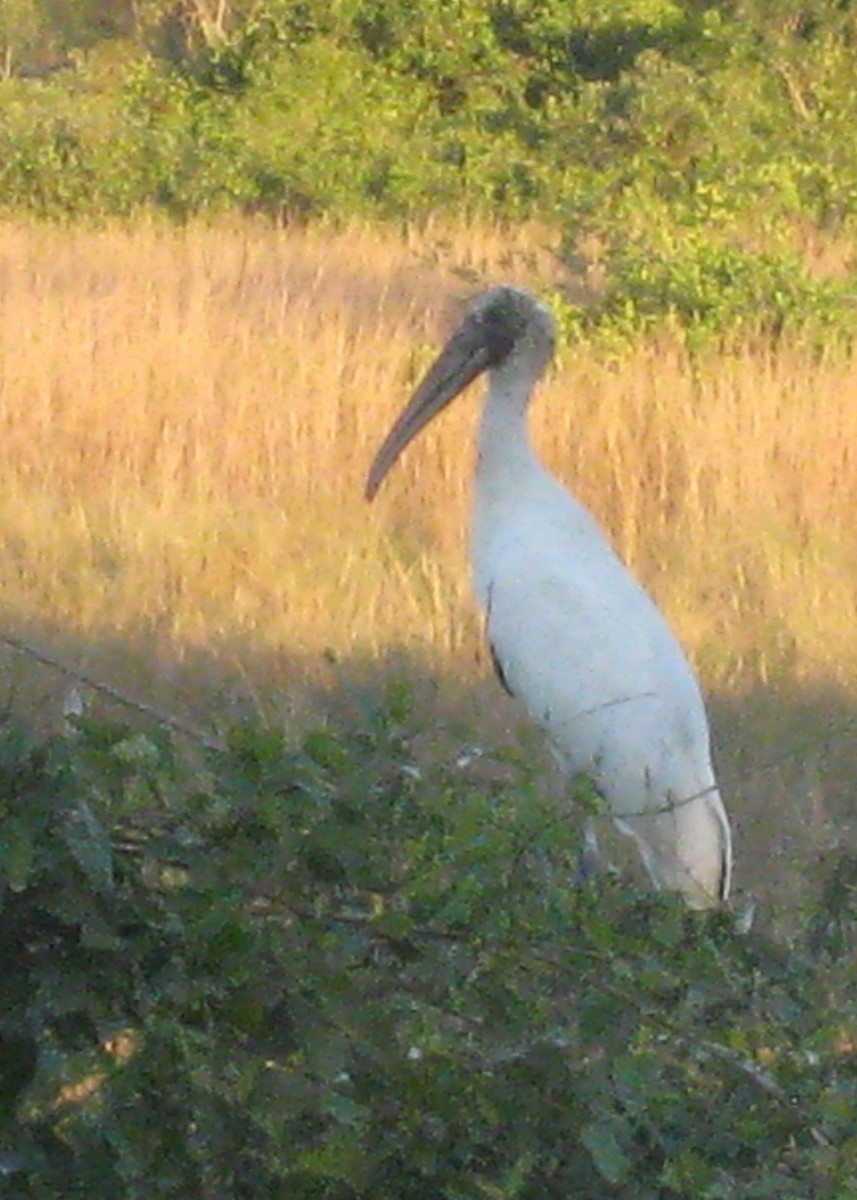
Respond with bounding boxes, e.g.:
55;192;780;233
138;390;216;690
366;322;489;500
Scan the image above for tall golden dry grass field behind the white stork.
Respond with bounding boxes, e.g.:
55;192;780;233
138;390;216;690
0;223;857;907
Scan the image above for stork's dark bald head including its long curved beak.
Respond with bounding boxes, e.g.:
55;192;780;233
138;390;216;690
366;286;556;500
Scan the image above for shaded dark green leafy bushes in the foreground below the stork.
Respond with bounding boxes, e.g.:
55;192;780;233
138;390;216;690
0;696;857;1200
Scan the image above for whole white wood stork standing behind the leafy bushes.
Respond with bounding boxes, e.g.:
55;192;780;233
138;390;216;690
366;287;732;908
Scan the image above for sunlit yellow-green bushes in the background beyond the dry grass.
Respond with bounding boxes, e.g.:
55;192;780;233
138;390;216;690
0;0;857;347
